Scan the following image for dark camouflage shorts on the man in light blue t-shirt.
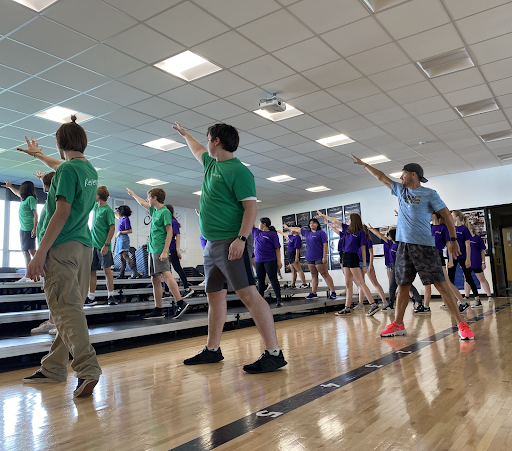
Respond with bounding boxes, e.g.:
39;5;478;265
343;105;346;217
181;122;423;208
395;243;445;285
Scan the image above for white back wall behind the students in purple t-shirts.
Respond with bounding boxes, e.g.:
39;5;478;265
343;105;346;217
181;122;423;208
258;166;512;294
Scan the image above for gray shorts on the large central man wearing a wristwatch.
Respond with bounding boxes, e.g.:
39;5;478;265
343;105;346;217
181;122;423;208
203;235;256;293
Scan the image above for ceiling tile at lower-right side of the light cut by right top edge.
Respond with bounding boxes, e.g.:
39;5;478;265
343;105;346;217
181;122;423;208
376;0;450;39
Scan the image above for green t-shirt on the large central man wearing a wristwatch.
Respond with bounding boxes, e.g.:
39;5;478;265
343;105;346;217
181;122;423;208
199;152;256;241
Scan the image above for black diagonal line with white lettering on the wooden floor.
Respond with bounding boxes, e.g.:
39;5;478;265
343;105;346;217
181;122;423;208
171;302;511;451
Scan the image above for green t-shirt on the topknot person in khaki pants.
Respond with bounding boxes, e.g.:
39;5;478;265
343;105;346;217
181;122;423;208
41;159;98;247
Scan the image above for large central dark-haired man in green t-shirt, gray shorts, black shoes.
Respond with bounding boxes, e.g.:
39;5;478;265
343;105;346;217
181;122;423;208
174;122;287;373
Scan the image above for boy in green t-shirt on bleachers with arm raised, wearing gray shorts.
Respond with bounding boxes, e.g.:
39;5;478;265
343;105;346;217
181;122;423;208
126;188;189;319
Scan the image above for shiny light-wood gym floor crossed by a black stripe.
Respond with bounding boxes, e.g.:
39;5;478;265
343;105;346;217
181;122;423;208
0;298;512;451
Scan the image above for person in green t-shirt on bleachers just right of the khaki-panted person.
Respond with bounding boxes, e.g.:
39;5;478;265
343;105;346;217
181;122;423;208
84;185;119;306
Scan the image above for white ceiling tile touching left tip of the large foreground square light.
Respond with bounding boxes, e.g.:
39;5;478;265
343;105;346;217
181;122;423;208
71;45;144;78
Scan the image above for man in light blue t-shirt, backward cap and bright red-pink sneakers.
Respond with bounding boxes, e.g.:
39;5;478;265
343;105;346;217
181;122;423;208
352;155;475;340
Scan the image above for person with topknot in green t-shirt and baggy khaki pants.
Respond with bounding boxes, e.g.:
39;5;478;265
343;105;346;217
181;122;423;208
18;116;101;397
